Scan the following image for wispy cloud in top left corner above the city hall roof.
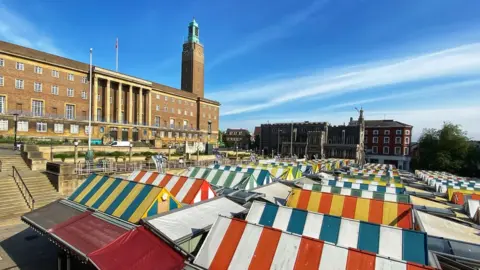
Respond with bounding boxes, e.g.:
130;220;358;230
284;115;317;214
0;3;64;55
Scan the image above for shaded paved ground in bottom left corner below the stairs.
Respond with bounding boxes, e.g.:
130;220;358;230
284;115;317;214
0;223;57;270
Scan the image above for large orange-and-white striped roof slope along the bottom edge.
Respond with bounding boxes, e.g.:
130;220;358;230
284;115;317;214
194;216;432;270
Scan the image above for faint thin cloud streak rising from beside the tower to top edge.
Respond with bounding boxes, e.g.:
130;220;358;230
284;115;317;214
207;0;328;69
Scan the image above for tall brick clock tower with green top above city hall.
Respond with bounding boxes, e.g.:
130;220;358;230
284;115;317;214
181;18;204;98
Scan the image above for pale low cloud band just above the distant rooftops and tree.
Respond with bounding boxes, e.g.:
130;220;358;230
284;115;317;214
221;106;480;141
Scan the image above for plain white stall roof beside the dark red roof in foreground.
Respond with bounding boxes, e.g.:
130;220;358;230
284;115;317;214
144;197;246;244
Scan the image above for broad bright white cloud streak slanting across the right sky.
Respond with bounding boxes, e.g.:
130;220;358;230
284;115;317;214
216;43;480;115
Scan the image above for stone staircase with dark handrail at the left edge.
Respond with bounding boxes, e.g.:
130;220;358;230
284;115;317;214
0;149;61;221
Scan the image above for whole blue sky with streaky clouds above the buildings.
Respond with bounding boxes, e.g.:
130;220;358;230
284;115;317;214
0;0;480;141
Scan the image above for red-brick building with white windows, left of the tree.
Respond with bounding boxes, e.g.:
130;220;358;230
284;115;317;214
350;120;413;170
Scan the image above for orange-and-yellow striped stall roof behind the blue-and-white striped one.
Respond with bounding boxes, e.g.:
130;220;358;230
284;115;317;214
287;188;413;229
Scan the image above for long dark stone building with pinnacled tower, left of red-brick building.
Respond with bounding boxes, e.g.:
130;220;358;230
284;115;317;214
261;110;365;163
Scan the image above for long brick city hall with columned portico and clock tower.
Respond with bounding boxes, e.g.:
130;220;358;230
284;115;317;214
0;20;220;144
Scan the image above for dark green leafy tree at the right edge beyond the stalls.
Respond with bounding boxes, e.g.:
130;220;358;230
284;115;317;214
412;122;480;176
